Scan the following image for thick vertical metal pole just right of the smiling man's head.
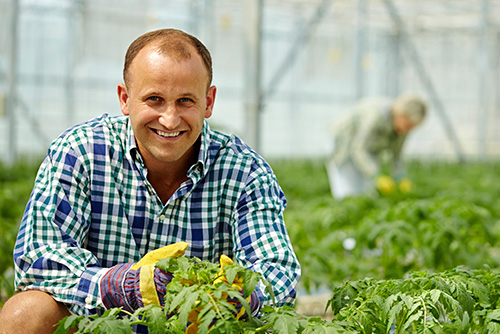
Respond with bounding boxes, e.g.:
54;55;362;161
244;0;263;151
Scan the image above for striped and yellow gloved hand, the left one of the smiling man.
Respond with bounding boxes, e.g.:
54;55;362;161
99;242;188;312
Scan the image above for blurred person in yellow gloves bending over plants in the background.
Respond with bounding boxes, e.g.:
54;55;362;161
327;94;427;199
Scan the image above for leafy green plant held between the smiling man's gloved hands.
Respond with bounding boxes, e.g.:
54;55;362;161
56;256;271;333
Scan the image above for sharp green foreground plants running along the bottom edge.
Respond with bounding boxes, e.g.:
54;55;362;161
56;257;500;334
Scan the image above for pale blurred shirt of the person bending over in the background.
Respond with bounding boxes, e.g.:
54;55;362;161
331;98;406;178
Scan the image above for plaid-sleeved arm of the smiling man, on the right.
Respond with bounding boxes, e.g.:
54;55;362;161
233;165;301;306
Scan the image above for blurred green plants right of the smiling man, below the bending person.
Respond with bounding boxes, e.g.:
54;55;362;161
273;160;500;292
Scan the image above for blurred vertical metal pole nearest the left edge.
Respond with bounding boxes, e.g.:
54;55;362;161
6;0;19;164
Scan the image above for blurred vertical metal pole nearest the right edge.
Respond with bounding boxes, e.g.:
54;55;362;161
477;0;490;159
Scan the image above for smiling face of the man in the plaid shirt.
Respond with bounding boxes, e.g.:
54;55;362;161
118;46;216;166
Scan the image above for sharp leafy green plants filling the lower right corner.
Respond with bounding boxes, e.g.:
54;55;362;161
328;267;500;334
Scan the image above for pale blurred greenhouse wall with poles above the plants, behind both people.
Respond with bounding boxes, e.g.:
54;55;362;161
0;0;500;162
